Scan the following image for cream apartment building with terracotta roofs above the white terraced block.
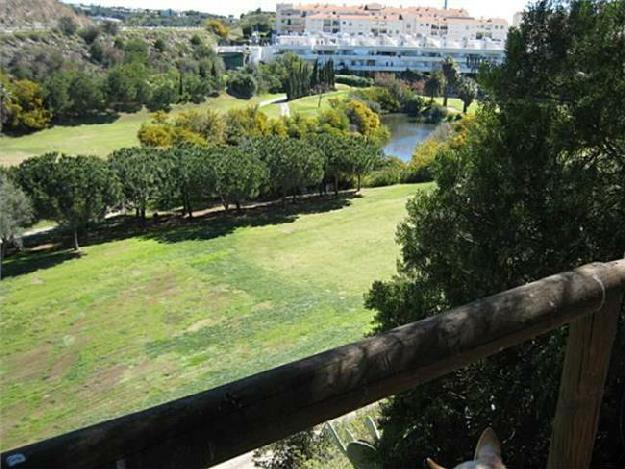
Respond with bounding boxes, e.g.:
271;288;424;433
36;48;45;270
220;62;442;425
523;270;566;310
276;3;509;42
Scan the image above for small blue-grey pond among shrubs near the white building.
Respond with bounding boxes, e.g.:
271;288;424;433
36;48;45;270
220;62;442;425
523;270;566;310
382;114;436;161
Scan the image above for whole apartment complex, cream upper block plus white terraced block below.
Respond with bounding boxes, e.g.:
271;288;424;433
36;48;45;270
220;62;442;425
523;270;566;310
272;3;508;74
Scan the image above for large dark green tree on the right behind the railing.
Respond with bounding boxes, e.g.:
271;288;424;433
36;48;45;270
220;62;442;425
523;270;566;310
367;0;625;467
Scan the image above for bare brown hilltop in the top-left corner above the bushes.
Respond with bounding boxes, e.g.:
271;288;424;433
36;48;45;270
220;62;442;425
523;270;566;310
0;0;91;30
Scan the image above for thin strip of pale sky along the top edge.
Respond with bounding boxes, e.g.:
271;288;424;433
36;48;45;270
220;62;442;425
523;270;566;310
65;0;527;22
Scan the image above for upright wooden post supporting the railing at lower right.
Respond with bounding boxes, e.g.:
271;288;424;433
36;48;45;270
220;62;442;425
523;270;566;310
547;268;623;469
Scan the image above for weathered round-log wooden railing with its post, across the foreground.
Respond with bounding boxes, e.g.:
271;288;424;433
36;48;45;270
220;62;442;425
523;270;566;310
0;260;625;469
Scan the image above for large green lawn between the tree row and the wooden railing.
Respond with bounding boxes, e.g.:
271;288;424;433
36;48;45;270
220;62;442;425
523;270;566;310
0;184;431;449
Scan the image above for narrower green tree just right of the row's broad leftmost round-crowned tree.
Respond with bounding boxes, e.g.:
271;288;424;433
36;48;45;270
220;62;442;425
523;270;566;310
109;148;168;223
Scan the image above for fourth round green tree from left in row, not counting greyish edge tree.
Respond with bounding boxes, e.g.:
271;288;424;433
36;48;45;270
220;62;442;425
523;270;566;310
213;146;267;210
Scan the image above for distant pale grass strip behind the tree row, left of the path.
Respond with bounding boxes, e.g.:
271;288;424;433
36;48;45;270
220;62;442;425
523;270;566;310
0;94;282;166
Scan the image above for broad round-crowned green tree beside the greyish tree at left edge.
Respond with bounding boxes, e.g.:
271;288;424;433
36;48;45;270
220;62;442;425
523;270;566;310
18;153;120;251
